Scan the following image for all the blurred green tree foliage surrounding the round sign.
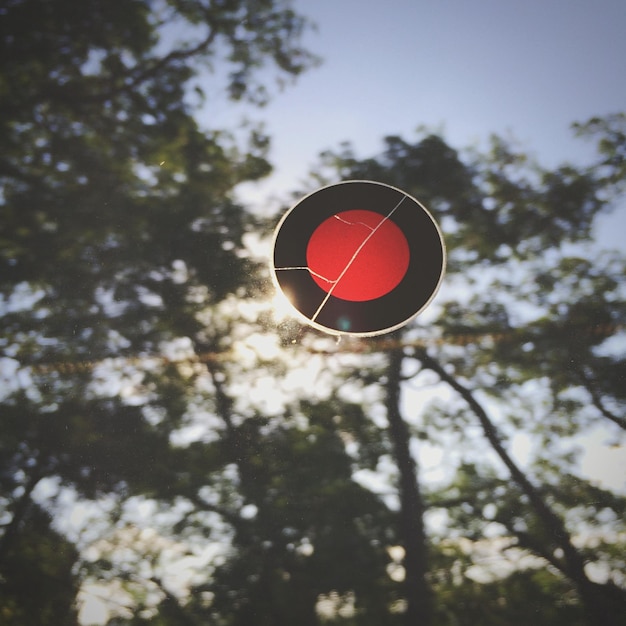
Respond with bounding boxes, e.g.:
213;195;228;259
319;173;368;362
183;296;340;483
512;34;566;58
0;0;626;626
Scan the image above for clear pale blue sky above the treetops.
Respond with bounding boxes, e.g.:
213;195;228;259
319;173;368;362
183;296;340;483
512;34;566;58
213;0;626;247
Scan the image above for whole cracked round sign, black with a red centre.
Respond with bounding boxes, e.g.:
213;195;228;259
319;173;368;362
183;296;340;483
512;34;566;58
271;180;446;336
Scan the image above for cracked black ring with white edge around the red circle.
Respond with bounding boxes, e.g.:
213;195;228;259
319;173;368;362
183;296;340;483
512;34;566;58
271;180;446;336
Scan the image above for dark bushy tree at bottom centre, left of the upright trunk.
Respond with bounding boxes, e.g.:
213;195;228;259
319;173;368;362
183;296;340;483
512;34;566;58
197;384;400;626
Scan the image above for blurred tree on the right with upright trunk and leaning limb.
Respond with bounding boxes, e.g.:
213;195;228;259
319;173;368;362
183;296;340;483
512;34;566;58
310;115;626;624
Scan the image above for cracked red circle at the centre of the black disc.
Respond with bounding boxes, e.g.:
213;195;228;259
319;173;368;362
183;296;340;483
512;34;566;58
306;209;410;302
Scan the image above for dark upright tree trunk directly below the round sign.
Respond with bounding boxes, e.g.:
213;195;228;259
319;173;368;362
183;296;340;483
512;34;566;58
385;349;433;626
